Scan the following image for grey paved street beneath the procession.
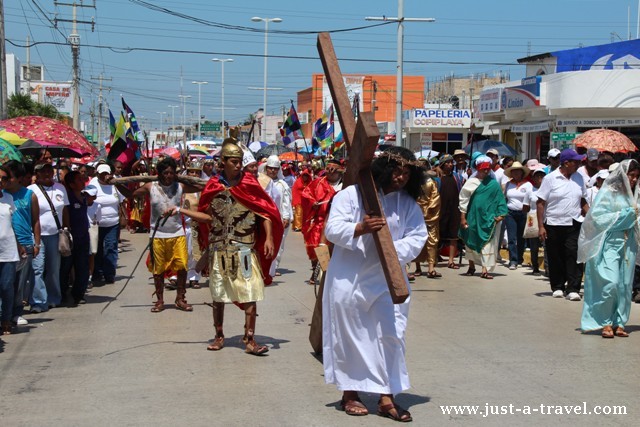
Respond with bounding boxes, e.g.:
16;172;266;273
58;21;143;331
0;233;640;426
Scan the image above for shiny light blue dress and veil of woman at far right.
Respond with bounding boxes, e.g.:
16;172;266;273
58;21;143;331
581;191;638;332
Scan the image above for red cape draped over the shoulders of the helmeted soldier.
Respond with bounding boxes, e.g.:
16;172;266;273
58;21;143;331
198;172;284;285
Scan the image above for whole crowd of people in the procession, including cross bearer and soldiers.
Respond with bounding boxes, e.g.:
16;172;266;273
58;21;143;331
0;136;640;421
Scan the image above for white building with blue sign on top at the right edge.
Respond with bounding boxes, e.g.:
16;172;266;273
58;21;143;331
478;40;640;158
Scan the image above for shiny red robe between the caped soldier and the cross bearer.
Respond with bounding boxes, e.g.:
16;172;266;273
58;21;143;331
301;177;336;261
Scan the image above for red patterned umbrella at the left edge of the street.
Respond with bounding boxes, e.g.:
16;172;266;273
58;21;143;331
0;116;98;155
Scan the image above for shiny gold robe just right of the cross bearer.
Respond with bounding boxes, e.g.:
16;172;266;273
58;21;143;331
414;179;440;265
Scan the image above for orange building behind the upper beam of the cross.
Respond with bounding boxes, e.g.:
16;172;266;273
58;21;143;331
297;74;424;138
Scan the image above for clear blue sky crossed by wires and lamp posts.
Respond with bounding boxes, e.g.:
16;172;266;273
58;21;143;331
4;0;638;133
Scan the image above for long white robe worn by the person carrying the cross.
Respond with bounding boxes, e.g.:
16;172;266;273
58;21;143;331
322;186;427;394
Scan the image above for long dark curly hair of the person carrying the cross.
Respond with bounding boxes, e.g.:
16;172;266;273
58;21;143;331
371;147;424;200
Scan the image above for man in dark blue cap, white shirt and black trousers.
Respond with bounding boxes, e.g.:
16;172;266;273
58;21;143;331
537;148;589;301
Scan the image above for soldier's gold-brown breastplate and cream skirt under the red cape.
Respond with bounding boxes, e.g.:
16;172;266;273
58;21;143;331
209;189;264;303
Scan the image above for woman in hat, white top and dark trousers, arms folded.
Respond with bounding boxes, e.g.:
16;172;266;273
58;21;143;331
504;162;533;270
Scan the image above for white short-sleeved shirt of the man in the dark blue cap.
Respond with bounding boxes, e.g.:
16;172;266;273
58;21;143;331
538;168;587;225
